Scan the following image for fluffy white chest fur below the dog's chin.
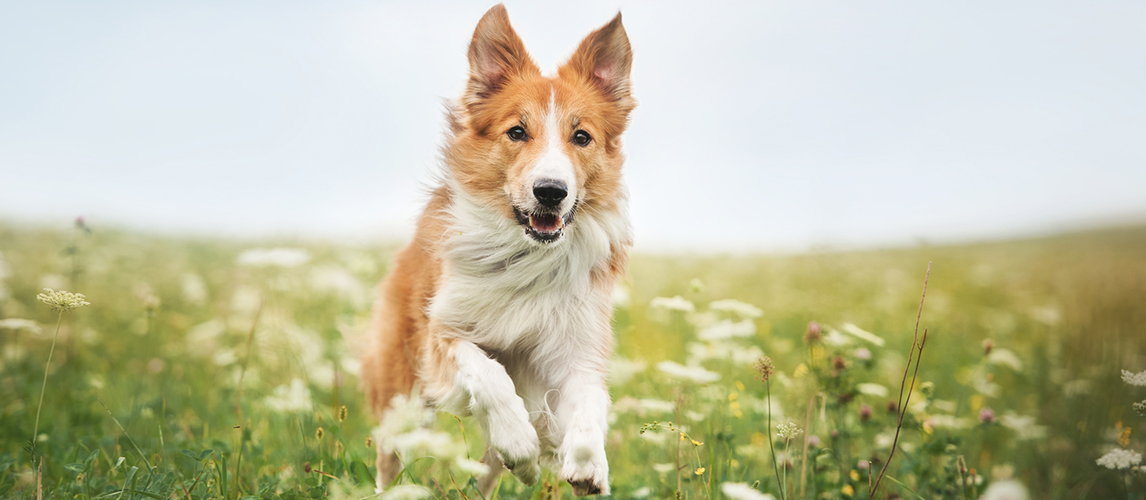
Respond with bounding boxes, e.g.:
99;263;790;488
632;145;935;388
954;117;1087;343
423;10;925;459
427;185;629;351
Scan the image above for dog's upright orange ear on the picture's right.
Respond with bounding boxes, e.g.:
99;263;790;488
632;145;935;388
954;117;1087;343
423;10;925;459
558;13;633;102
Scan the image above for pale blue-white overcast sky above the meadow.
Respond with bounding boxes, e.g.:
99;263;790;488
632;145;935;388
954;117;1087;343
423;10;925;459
0;0;1146;251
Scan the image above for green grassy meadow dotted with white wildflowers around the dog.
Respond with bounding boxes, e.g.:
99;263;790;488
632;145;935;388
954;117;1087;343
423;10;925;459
0;222;1146;500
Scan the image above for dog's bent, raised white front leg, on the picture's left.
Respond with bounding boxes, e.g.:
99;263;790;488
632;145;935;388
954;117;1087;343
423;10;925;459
442;339;541;486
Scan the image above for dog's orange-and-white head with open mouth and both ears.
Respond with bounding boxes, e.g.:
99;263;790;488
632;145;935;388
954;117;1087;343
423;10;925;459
446;5;635;243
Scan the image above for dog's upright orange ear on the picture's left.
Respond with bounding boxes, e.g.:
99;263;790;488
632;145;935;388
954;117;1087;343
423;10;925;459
466;3;541;99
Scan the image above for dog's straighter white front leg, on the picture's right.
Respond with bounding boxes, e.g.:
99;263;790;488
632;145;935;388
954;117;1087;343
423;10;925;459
557;369;609;497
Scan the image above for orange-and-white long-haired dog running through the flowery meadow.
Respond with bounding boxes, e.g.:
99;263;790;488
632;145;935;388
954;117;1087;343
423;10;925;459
362;5;636;495
